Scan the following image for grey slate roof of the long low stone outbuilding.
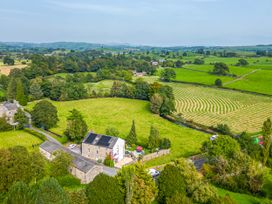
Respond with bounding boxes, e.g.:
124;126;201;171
40;141;96;173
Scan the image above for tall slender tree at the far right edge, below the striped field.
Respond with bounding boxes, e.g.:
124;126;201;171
263;118;272;165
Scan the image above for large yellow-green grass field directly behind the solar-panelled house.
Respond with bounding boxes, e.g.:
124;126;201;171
29;98;209;165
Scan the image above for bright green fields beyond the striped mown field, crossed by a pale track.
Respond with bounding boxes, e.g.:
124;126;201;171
170;56;272;95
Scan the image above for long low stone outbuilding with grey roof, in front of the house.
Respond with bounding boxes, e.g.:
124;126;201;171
40;141;116;184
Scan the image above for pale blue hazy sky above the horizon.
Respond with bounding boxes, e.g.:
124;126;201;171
0;0;272;46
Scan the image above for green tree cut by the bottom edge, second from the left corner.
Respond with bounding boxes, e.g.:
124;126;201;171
36;178;69;204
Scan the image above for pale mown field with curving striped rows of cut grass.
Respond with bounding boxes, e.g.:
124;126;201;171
169;83;272;132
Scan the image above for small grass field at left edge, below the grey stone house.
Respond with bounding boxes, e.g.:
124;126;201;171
0;131;42;149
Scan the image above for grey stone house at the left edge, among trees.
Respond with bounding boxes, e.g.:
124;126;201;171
0;100;21;125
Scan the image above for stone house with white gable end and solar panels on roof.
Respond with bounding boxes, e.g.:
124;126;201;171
81;132;125;162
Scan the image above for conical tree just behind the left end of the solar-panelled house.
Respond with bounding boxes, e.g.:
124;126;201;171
64;109;88;142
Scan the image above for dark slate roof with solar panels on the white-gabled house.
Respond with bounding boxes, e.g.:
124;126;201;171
83;132;118;149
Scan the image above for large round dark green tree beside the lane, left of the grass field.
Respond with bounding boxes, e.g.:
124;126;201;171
31;100;59;130
